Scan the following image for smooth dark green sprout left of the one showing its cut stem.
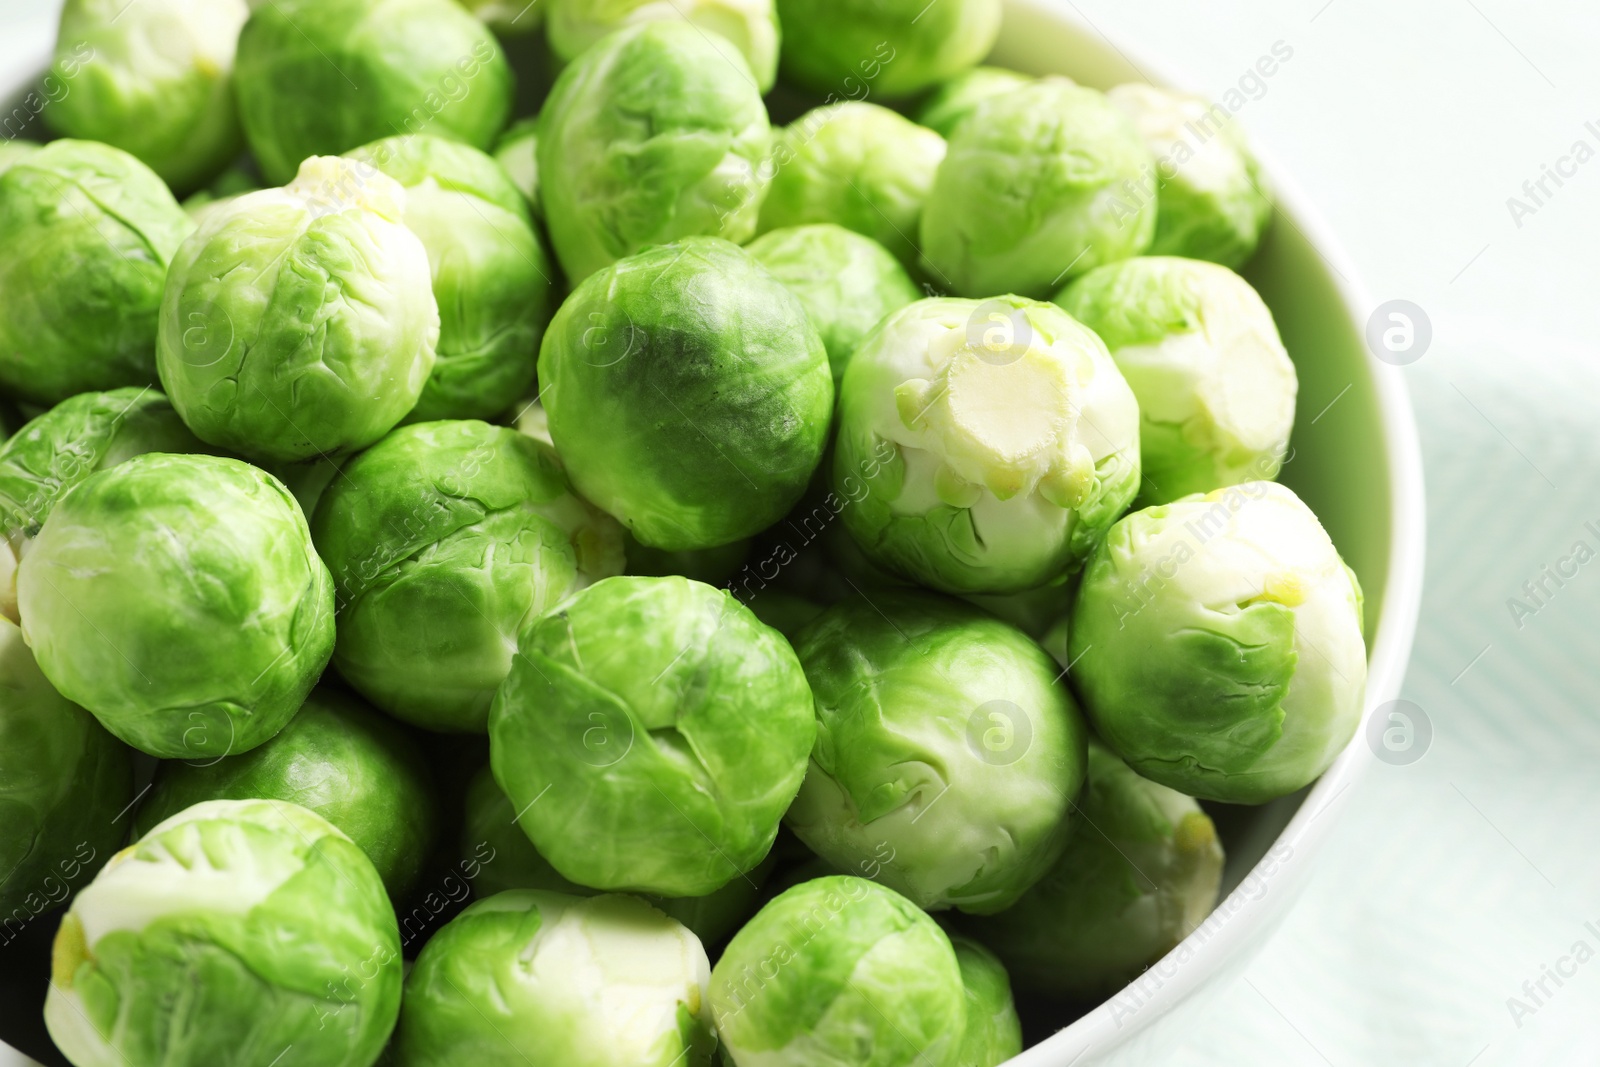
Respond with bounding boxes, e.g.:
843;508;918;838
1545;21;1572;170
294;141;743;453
539;236;834;550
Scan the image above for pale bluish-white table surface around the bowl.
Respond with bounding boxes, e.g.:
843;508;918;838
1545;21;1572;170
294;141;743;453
0;0;1600;1067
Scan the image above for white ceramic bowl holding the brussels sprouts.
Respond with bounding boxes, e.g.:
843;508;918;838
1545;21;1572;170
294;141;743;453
0;0;1422;1067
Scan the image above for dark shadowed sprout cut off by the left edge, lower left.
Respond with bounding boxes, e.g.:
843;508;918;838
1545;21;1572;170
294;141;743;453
0;619;133;921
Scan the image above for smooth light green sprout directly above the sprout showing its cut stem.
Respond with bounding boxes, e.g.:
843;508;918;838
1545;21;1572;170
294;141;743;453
922;78;1155;298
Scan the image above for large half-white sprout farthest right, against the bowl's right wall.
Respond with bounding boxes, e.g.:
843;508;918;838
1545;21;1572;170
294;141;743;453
1068;482;1366;803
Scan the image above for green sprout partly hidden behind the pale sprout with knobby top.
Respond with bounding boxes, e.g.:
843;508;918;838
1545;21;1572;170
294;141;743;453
347;136;550;422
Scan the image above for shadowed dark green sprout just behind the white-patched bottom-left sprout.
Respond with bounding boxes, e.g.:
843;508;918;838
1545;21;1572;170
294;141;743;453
133;689;437;899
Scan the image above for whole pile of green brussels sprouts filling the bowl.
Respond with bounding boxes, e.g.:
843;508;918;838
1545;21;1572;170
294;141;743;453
0;0;1365;1067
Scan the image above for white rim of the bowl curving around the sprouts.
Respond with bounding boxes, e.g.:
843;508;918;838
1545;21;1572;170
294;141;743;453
1003;0;1426;1067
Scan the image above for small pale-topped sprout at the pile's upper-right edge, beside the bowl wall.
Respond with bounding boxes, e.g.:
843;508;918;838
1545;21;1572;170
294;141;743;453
1107;85;1272;267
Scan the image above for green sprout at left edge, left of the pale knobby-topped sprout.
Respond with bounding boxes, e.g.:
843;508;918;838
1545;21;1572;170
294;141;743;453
0;141;194;405
